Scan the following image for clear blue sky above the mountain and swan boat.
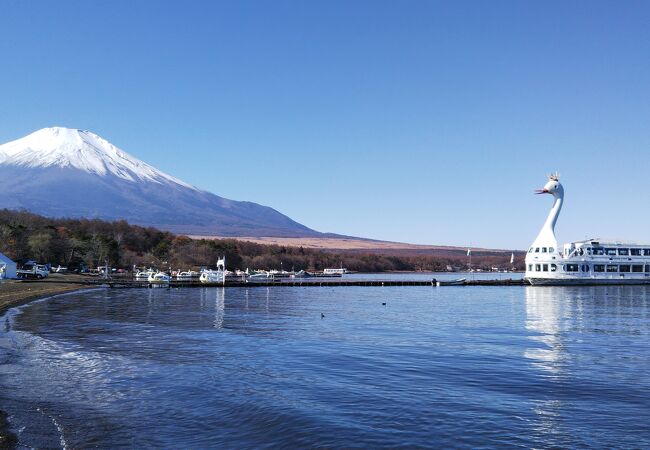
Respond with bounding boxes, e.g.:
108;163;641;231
0;0;650;248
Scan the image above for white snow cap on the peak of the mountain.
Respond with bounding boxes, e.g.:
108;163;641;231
0;127;196;189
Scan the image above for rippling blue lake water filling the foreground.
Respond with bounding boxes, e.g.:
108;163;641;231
0;278;650;448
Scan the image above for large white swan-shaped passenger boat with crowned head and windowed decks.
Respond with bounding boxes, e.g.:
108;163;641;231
525;175;650;285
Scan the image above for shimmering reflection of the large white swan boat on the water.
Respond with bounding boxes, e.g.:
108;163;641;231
523;286;650;443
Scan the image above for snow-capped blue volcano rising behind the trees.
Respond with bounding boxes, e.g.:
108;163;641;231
0;127;324;237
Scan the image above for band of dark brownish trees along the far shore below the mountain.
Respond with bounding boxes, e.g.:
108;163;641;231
0;209;510;272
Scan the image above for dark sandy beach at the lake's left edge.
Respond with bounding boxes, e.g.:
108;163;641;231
0;277;91;449
